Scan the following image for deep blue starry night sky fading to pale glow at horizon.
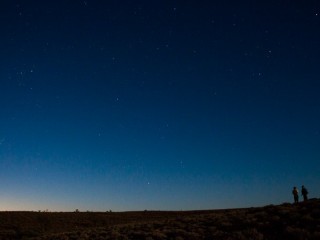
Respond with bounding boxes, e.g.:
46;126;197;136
0;0;320;211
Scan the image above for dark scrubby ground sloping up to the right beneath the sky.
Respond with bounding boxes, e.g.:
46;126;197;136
0;199;320;240
